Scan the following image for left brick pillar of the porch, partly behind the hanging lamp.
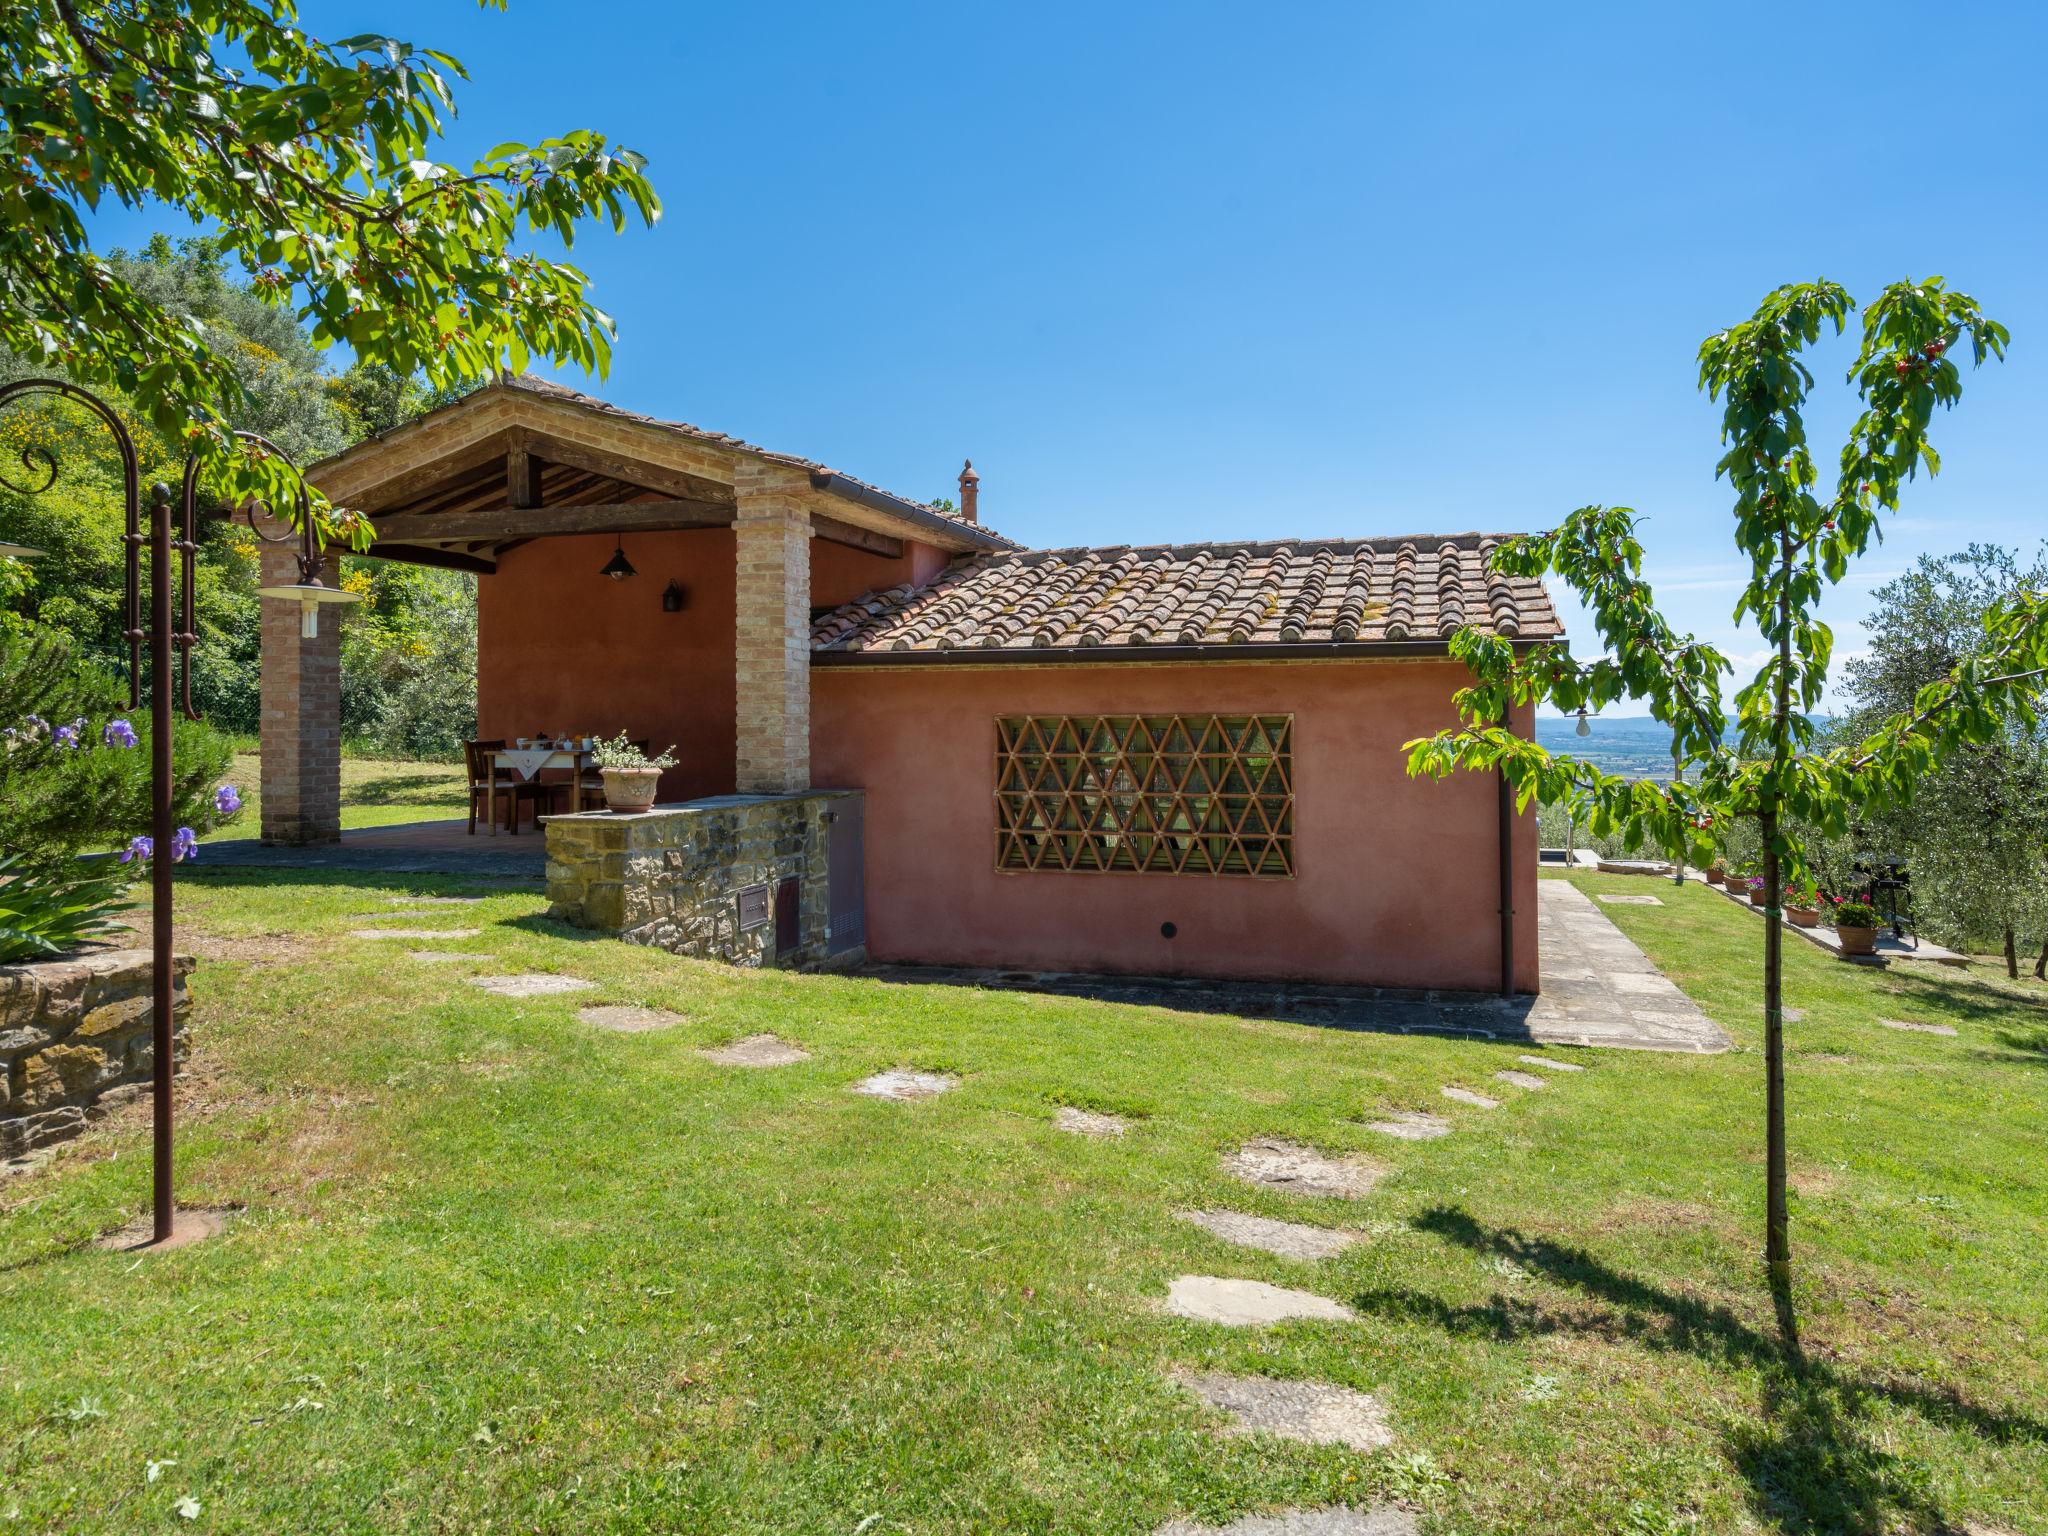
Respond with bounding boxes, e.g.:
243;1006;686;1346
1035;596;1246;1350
262;524;342;846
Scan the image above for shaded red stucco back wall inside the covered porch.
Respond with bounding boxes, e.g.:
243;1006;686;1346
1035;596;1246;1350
477;528;735;801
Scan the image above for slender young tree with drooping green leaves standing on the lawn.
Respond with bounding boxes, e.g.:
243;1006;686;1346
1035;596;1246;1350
1407;279;2048;1286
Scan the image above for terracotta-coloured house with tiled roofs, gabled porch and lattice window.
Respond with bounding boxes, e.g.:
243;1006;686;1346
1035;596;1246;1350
284;377;1561;991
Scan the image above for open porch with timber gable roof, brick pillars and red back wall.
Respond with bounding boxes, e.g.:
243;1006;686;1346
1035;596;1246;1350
262;377;1012;848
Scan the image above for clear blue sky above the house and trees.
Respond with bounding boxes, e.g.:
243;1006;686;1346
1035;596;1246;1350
83;0;2048;716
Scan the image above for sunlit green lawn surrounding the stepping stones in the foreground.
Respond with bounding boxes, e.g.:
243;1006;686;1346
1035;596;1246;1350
0;868;2048;1536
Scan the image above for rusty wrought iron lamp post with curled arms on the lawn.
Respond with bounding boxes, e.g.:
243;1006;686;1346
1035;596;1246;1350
0;379;356;1243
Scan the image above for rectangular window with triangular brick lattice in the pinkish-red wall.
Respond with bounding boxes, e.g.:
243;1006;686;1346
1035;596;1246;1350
995;715;1294;879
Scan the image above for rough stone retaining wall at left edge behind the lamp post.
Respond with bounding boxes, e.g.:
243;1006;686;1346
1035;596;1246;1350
0;950;193;1157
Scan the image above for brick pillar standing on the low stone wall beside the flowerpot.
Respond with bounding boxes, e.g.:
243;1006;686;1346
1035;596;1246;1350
733;463;811;795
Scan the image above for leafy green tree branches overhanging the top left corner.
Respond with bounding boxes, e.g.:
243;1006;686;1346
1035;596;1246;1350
0;0;659;549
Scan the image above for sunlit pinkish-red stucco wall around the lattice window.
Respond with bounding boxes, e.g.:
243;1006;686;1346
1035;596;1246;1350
811;662;1538;991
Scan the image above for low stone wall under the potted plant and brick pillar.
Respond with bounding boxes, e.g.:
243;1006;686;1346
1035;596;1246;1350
547;791;858;967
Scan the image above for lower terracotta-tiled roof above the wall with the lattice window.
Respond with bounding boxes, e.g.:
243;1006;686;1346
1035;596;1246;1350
811;532;1565;659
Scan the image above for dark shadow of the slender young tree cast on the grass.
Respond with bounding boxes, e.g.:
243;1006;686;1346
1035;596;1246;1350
1352;1206;2048;1536
